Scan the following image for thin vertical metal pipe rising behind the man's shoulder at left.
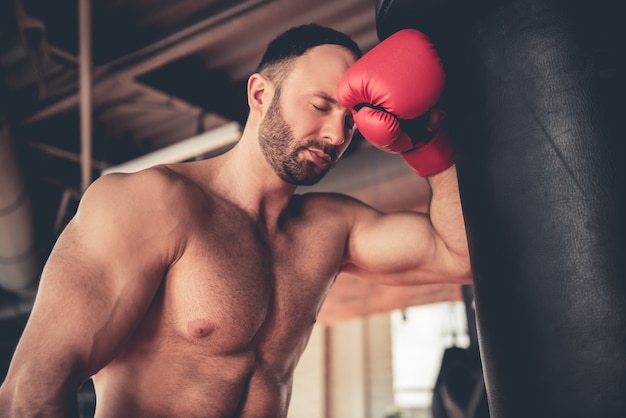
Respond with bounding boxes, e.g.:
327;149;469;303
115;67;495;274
78;0;93;192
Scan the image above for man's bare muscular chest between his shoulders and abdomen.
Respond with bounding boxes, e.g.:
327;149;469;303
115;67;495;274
152;216;345;354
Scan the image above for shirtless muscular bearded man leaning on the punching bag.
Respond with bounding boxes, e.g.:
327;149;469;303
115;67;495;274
0;25;470;418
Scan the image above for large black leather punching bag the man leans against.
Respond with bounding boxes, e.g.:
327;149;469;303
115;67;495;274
377;0;626;418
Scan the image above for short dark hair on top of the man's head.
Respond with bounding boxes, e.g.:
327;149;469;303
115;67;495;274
255;23;363;84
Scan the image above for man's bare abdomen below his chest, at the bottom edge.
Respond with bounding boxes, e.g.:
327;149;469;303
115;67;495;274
94;350;291;418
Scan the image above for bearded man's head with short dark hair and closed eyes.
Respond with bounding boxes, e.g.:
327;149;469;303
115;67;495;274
251;25;361;185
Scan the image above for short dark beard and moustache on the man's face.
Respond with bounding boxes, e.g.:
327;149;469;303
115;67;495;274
259;91;337;186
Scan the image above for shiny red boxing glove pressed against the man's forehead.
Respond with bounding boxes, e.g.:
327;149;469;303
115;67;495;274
338;29;454;177
